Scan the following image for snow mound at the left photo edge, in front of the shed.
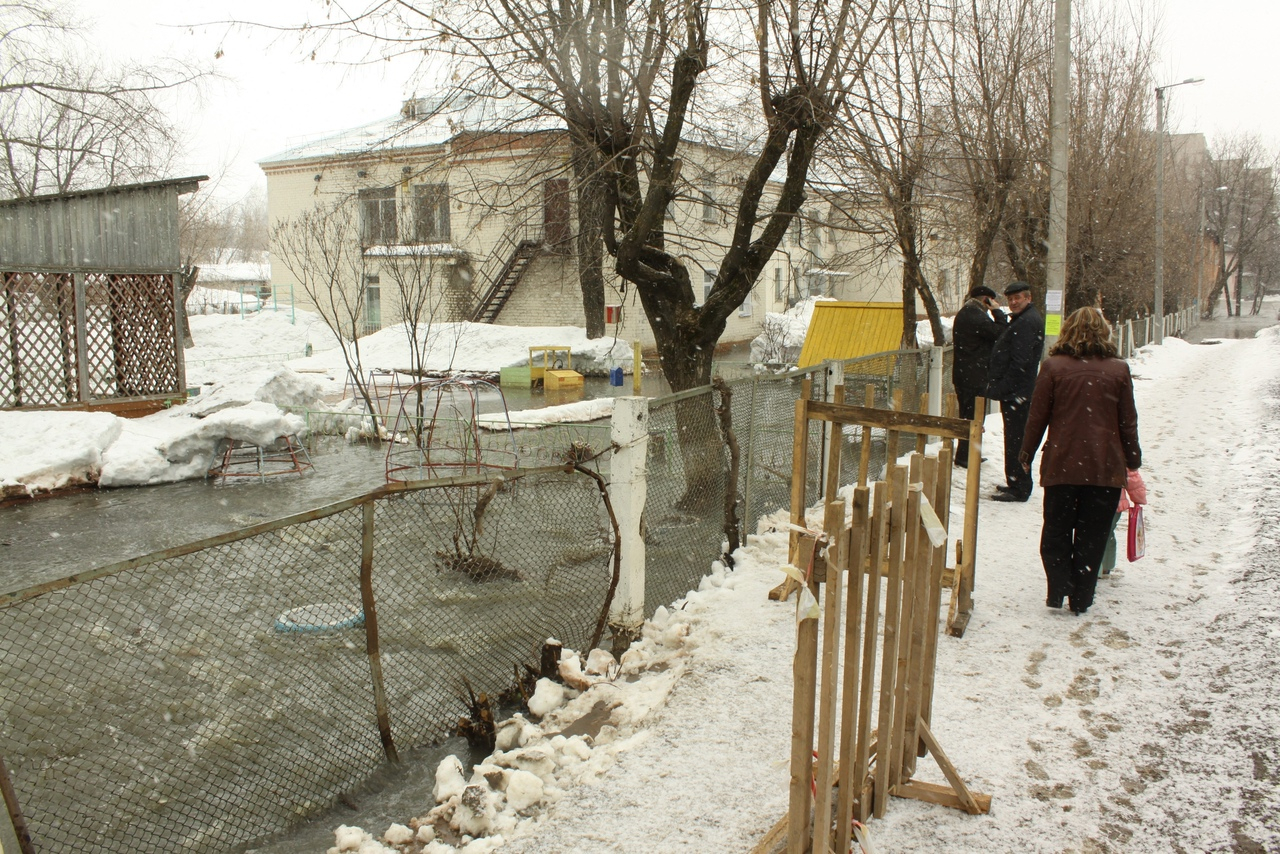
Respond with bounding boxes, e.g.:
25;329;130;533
0;412;122;498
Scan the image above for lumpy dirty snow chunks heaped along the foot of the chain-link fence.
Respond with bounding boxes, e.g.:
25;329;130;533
329;594;711;854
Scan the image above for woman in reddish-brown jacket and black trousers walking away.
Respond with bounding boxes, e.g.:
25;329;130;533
1019;309;1142;615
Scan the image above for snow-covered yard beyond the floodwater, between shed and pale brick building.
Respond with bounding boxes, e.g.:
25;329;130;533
0;311;631;498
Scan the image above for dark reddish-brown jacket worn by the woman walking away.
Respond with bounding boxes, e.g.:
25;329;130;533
1019;356;1142;487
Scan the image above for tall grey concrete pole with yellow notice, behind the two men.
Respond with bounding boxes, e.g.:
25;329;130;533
1044;0;1071;347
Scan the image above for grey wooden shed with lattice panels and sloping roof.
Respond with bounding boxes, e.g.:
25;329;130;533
0;175;207;415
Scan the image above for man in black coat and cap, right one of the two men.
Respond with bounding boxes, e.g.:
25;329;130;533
987;282;1044;501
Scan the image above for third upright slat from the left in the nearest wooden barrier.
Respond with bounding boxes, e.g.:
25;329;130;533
835;485;876;851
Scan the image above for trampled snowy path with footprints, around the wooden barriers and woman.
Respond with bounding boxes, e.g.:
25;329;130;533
322;328;1280;854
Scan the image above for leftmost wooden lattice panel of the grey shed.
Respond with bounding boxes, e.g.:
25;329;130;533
0;273;79;407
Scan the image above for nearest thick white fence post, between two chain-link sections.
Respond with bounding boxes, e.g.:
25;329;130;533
609;397;649;653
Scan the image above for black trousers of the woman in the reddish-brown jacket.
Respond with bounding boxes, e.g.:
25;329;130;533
1041;484;1120;609
